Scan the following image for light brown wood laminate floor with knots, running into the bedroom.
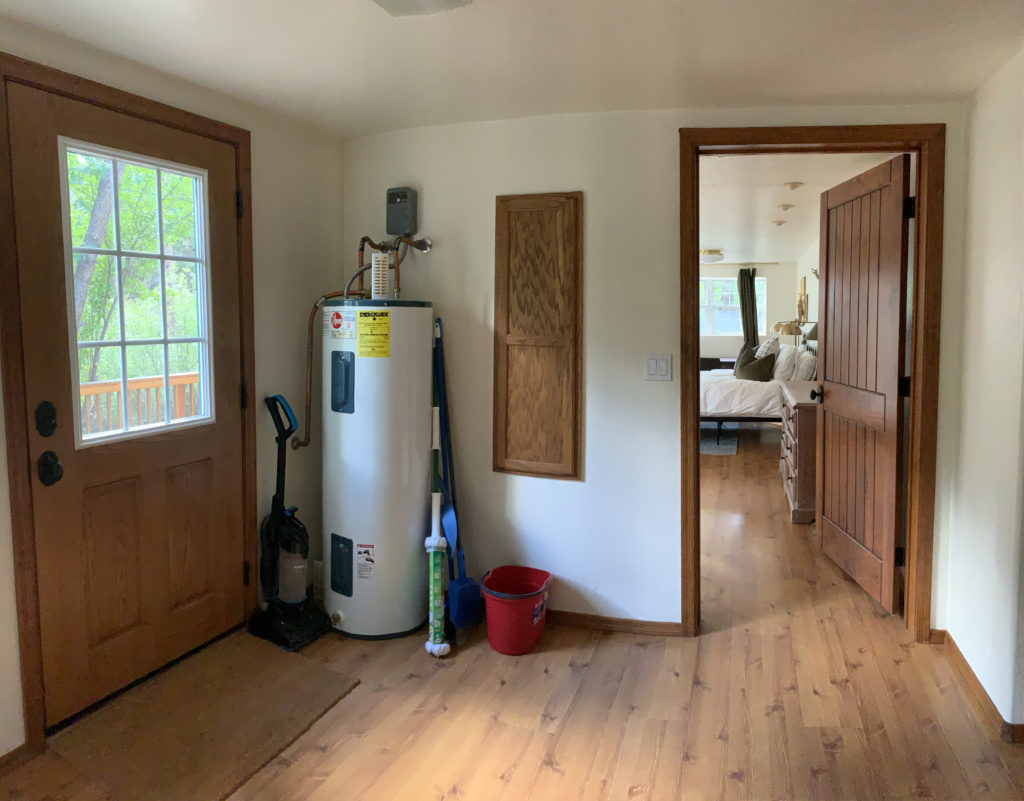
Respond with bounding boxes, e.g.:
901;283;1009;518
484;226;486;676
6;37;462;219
0;428;1024;801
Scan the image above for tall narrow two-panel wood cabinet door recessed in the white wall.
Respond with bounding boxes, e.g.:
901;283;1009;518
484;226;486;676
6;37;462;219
494;192;583;478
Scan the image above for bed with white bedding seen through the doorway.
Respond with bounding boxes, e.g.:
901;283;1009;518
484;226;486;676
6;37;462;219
700;344;816;440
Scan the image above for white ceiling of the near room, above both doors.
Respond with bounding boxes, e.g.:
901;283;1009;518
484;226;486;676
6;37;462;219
0;0;1024;135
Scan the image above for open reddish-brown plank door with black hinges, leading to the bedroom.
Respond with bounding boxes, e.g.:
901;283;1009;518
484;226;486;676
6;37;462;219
816;156;909;612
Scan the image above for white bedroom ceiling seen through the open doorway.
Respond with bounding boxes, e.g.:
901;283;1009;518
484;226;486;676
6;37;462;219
699;153;893;262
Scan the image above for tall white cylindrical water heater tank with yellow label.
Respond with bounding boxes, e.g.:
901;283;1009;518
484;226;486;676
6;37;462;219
322;300;433;638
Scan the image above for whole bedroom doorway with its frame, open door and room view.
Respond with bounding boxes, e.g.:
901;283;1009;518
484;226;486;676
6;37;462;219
680;126;943;640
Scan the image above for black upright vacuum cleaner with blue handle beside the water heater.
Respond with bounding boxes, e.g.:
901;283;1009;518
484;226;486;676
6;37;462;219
249;395;331;650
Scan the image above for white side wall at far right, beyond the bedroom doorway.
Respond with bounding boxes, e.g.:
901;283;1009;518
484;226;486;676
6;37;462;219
943;44;1024;723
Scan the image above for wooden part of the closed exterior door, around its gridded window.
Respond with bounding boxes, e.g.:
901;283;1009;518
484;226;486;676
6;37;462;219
7;82;245;725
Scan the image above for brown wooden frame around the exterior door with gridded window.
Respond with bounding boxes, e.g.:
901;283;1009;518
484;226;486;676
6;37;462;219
0;52;258;751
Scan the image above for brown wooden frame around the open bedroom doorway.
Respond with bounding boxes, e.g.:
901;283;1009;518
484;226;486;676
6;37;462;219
679;124;946;642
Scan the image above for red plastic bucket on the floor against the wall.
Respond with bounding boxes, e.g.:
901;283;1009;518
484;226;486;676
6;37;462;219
480;564;551;656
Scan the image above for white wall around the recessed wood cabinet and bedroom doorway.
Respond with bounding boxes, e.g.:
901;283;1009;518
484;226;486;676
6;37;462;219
345;106;965;627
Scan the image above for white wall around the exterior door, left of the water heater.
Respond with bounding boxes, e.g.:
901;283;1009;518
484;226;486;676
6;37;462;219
0;20;343;753
